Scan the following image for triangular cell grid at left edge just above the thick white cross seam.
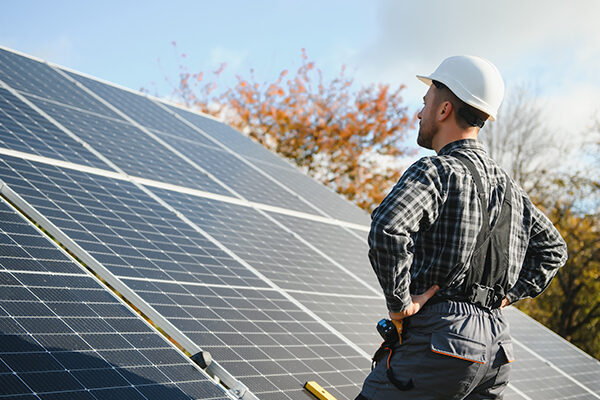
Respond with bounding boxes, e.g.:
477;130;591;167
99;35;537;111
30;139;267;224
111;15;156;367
0;89;107;168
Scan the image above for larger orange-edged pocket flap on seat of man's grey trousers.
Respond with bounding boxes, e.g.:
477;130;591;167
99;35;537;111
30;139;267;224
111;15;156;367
431;332;488;364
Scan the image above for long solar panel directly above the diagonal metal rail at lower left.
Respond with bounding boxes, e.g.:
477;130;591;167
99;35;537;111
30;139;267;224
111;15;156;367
0;158;369;399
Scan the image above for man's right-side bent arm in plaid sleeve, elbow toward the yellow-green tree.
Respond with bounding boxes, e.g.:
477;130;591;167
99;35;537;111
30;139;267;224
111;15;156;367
506;199;567;303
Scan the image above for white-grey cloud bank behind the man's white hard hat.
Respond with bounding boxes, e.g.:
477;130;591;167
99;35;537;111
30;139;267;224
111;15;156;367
354;0;600;111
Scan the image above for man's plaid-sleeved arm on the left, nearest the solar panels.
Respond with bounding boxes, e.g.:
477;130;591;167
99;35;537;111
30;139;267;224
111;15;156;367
369;158;443;316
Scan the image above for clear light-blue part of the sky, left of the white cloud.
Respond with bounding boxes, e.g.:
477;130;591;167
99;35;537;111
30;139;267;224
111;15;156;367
0;1;377;91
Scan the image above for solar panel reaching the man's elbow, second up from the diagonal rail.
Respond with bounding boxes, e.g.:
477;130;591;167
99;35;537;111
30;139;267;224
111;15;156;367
144;189;387;353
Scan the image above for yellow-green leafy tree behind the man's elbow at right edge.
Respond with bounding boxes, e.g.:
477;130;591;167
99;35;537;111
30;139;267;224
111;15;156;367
518;178;600;358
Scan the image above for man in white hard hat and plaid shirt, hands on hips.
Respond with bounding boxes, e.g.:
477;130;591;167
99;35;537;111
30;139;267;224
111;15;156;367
357;56;566;400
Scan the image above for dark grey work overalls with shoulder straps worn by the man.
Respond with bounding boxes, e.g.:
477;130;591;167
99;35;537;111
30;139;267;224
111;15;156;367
356;156;513;400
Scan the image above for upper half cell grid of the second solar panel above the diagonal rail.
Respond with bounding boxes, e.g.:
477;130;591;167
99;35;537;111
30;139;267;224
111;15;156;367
152;188;364;294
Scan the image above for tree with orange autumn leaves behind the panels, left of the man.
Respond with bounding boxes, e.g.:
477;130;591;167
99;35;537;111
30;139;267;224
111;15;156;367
166;50;416;210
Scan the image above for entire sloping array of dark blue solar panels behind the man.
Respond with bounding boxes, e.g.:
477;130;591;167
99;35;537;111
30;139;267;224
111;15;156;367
0;44;600;400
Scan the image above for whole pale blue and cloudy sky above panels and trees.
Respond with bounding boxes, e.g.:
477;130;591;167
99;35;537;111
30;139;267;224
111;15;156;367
0;0;600;154
